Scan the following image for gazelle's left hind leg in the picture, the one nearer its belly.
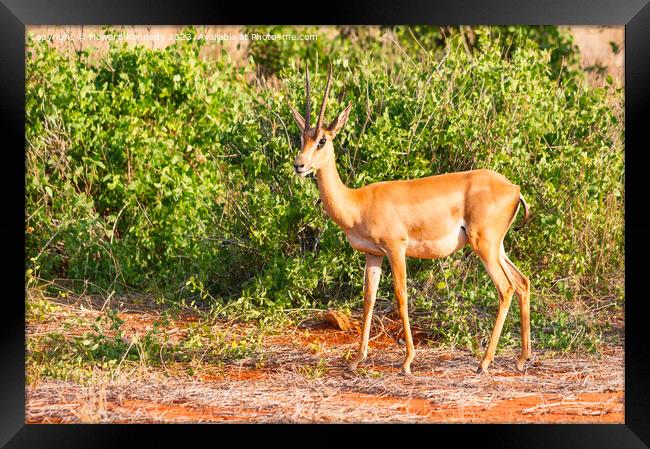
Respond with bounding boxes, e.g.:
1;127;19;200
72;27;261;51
472;235;516;373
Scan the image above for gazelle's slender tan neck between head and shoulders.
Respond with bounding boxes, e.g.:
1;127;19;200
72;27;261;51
316;155;357;229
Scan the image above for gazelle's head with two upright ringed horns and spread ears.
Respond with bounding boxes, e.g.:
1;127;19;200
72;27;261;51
289;62;352;178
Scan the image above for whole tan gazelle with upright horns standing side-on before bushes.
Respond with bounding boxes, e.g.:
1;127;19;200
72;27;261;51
289;63;531;374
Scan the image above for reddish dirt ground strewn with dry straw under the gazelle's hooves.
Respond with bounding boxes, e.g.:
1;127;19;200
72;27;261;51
26;298;624;423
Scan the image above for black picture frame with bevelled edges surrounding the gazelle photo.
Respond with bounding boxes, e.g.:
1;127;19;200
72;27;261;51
0;0;650;449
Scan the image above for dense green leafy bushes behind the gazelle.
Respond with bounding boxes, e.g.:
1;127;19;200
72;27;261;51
25;27;624;346
